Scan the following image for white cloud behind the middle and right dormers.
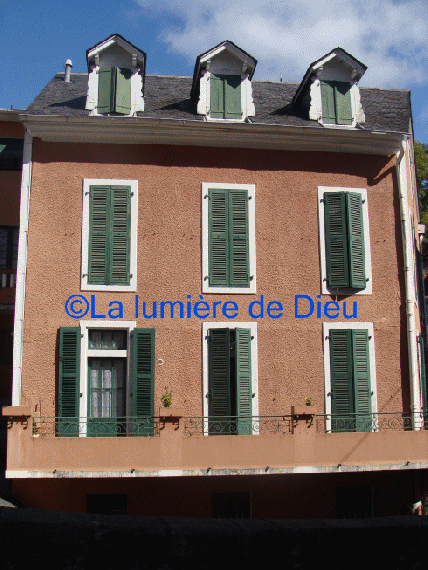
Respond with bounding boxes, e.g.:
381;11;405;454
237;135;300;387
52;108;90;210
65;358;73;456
135;0;428;87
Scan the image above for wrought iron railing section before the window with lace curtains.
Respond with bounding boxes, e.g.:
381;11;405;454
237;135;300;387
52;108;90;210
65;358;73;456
33;416;160;437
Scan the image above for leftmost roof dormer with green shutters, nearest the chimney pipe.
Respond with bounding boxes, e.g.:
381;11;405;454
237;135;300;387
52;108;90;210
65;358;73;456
86;34;146;116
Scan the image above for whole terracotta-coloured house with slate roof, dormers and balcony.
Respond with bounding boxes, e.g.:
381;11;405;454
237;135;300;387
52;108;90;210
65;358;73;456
3;35;428;518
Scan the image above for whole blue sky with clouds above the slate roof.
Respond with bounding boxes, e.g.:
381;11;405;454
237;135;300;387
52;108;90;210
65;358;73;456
0;0;428;143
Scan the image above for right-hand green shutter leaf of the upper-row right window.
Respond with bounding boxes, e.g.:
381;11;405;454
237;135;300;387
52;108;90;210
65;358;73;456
346;192;366;289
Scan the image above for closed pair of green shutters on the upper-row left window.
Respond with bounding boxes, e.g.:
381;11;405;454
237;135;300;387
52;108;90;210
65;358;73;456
88;186;131;285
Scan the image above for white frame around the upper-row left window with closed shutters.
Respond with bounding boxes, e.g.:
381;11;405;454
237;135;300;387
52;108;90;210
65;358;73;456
80;178;138;291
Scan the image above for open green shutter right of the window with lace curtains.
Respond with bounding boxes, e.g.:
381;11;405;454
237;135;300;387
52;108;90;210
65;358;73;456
132;329;155;435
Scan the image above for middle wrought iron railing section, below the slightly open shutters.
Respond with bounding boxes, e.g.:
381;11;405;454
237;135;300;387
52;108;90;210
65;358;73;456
183;416;293;436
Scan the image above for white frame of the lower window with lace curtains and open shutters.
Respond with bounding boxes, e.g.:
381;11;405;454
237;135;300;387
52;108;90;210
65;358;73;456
79;321;136;437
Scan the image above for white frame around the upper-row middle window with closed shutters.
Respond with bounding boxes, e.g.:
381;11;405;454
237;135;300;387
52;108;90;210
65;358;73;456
202;182;256;295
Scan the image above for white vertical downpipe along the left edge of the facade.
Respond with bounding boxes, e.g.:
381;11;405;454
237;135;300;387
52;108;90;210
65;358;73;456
12;130;33;406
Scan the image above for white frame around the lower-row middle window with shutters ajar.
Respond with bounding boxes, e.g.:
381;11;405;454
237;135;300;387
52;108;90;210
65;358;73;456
202;322;259;435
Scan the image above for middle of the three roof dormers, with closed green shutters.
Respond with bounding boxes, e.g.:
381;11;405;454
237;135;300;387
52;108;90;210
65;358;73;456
191;40;257;121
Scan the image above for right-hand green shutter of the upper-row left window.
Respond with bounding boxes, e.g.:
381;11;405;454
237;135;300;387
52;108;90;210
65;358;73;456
109;186;131;285
